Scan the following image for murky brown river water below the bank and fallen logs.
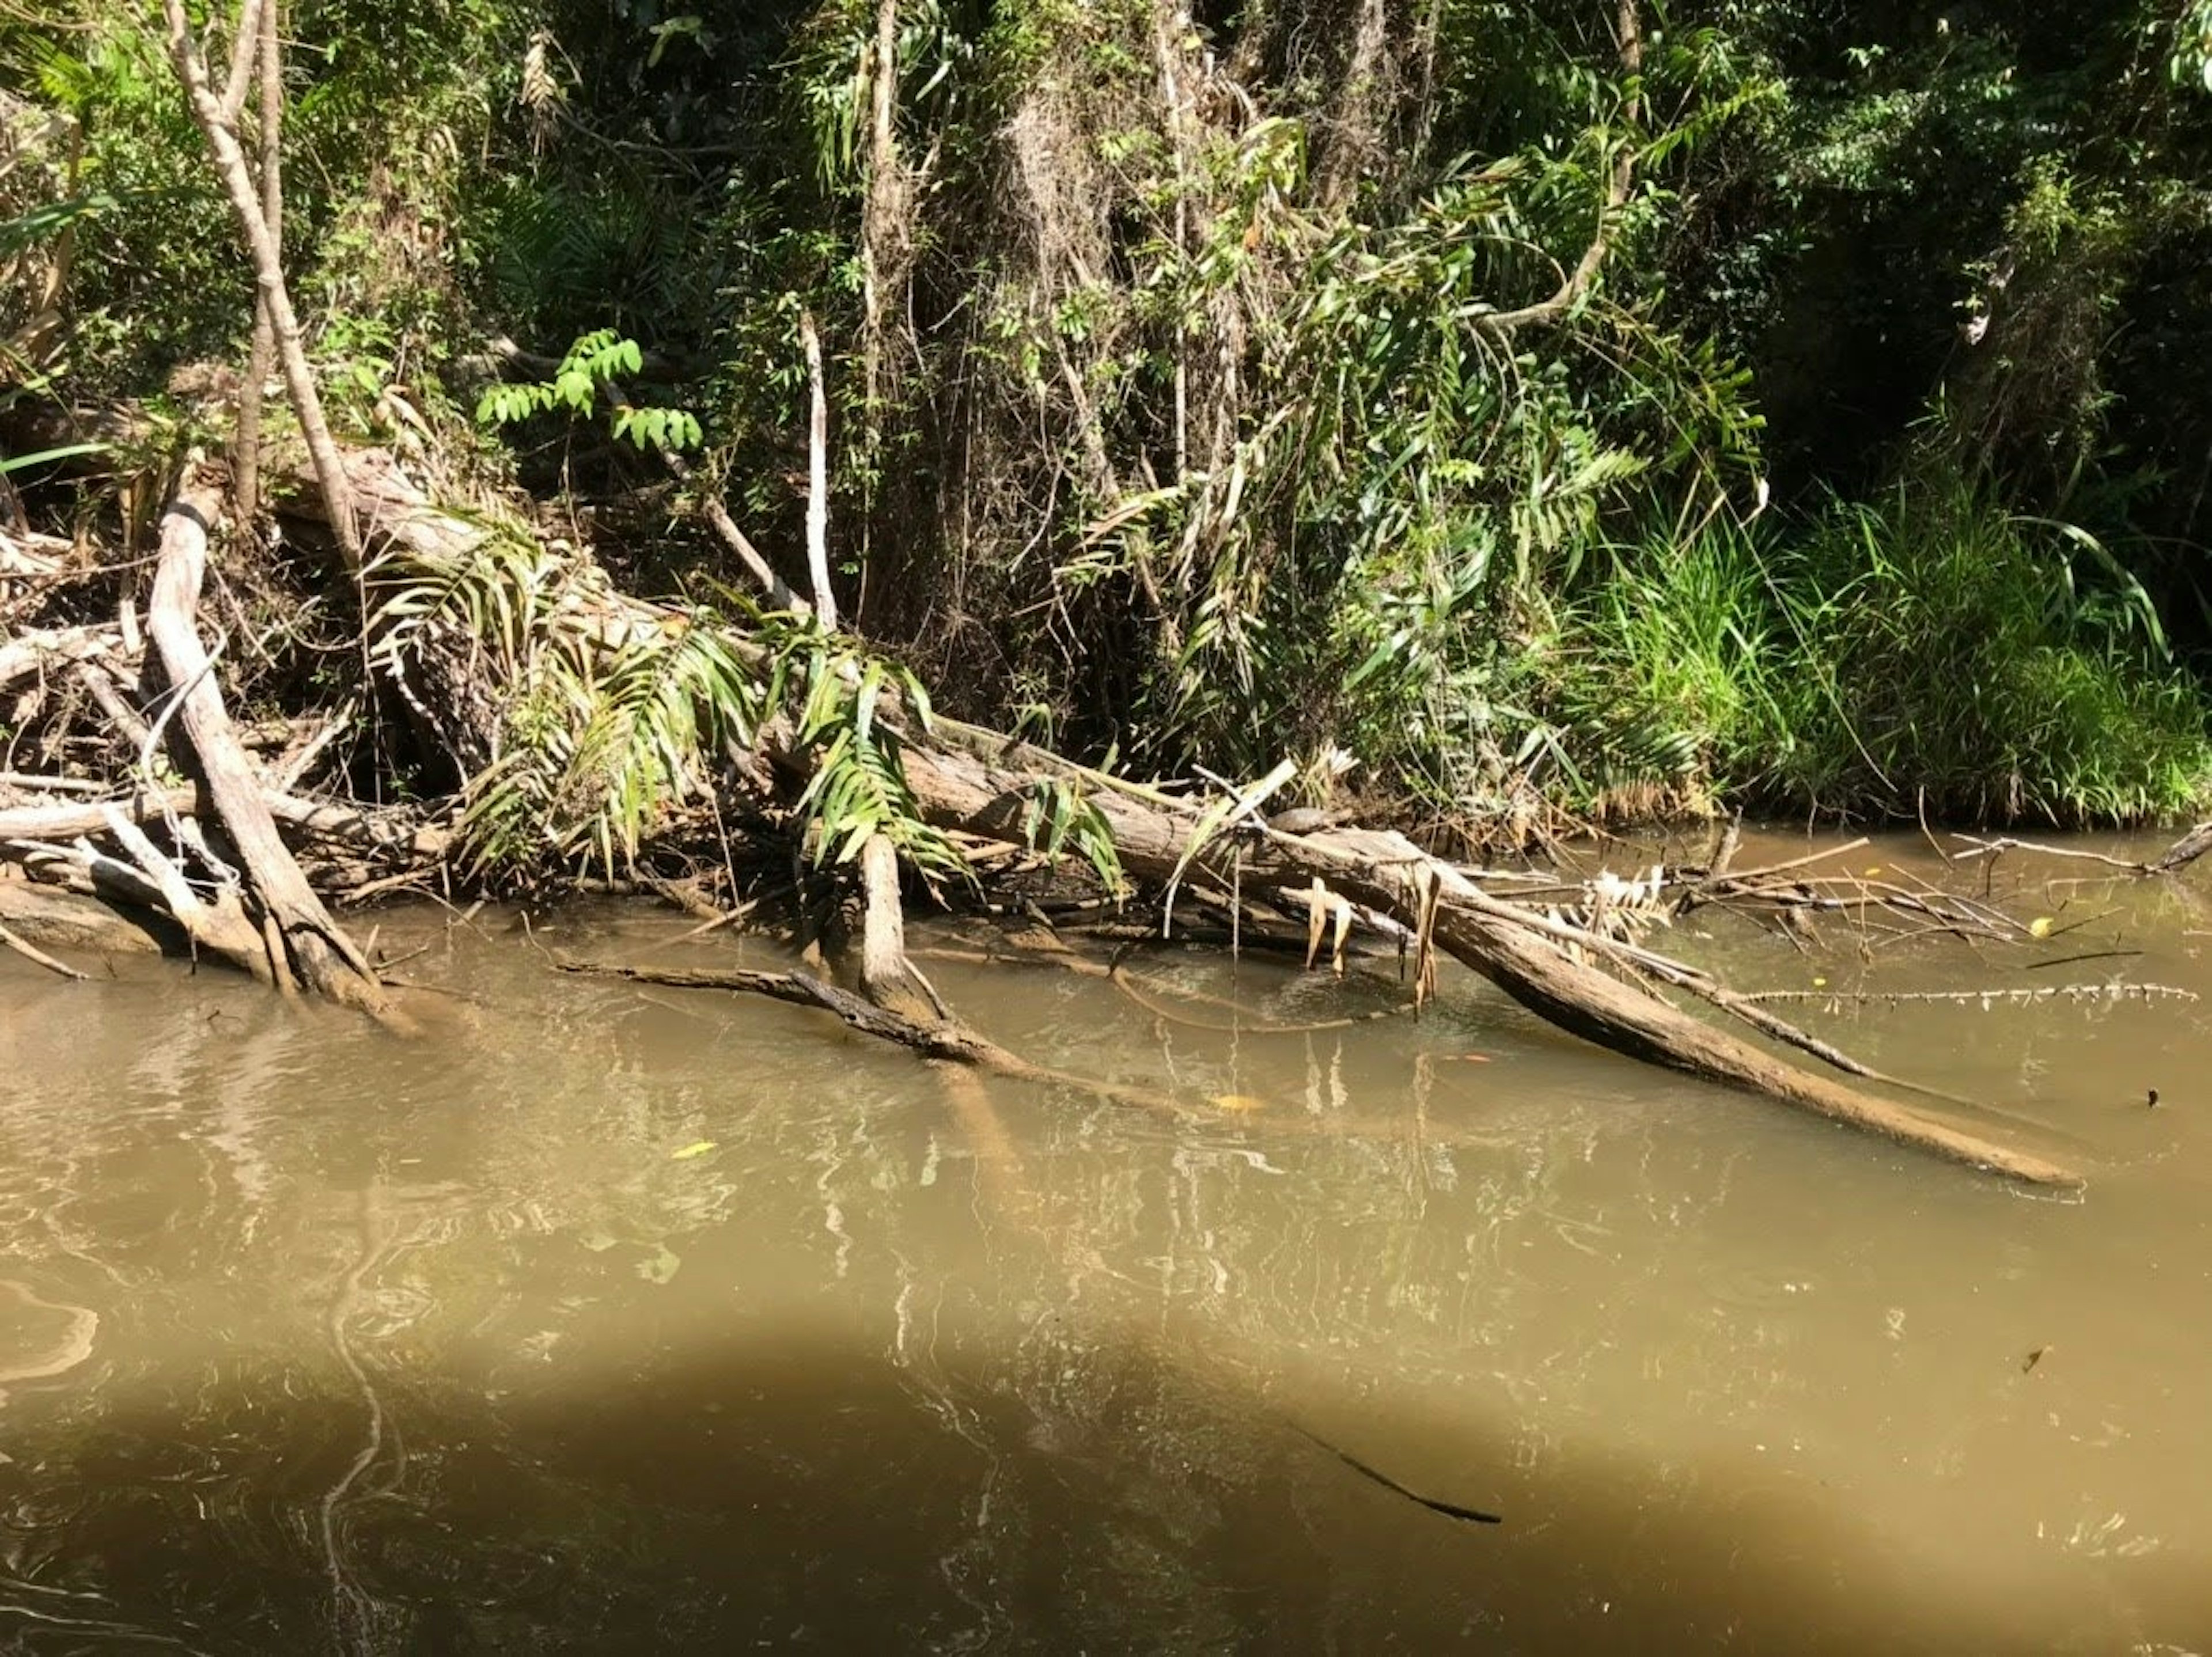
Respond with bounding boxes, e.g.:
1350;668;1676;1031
0;843;2212;1652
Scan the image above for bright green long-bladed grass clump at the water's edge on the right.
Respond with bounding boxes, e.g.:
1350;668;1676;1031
1557;487;2212;825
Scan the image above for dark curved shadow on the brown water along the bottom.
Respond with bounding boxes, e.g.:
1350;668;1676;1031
0;1323;2205;1652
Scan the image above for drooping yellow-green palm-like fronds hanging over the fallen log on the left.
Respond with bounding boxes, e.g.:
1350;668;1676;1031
369;520;967;881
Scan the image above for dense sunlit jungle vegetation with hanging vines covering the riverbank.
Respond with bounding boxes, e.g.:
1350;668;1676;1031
0;0;2212;856
